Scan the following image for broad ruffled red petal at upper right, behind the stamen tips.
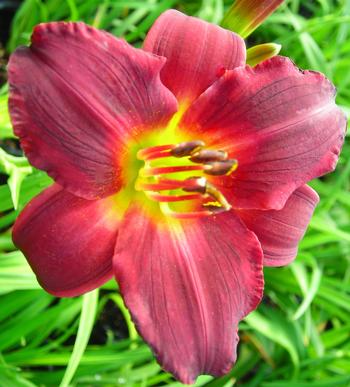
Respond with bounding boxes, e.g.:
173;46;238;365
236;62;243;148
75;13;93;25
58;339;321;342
182;57;346;209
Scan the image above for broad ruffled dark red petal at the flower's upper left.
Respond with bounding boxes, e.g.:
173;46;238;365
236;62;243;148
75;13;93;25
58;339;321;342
9;22;177;199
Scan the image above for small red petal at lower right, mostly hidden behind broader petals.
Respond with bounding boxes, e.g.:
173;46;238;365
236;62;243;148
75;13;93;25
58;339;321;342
237;185;319;266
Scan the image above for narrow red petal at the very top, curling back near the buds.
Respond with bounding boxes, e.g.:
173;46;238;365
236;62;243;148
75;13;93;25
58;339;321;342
144;10;246;103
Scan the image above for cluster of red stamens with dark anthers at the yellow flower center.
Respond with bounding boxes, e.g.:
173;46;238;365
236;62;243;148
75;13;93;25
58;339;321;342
135;140;237;219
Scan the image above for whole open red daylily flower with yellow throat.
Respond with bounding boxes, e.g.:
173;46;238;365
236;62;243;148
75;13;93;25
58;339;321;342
9;10;346;383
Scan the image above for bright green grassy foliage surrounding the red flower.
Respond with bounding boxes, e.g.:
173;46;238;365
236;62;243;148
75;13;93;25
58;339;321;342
0;0;350;387
